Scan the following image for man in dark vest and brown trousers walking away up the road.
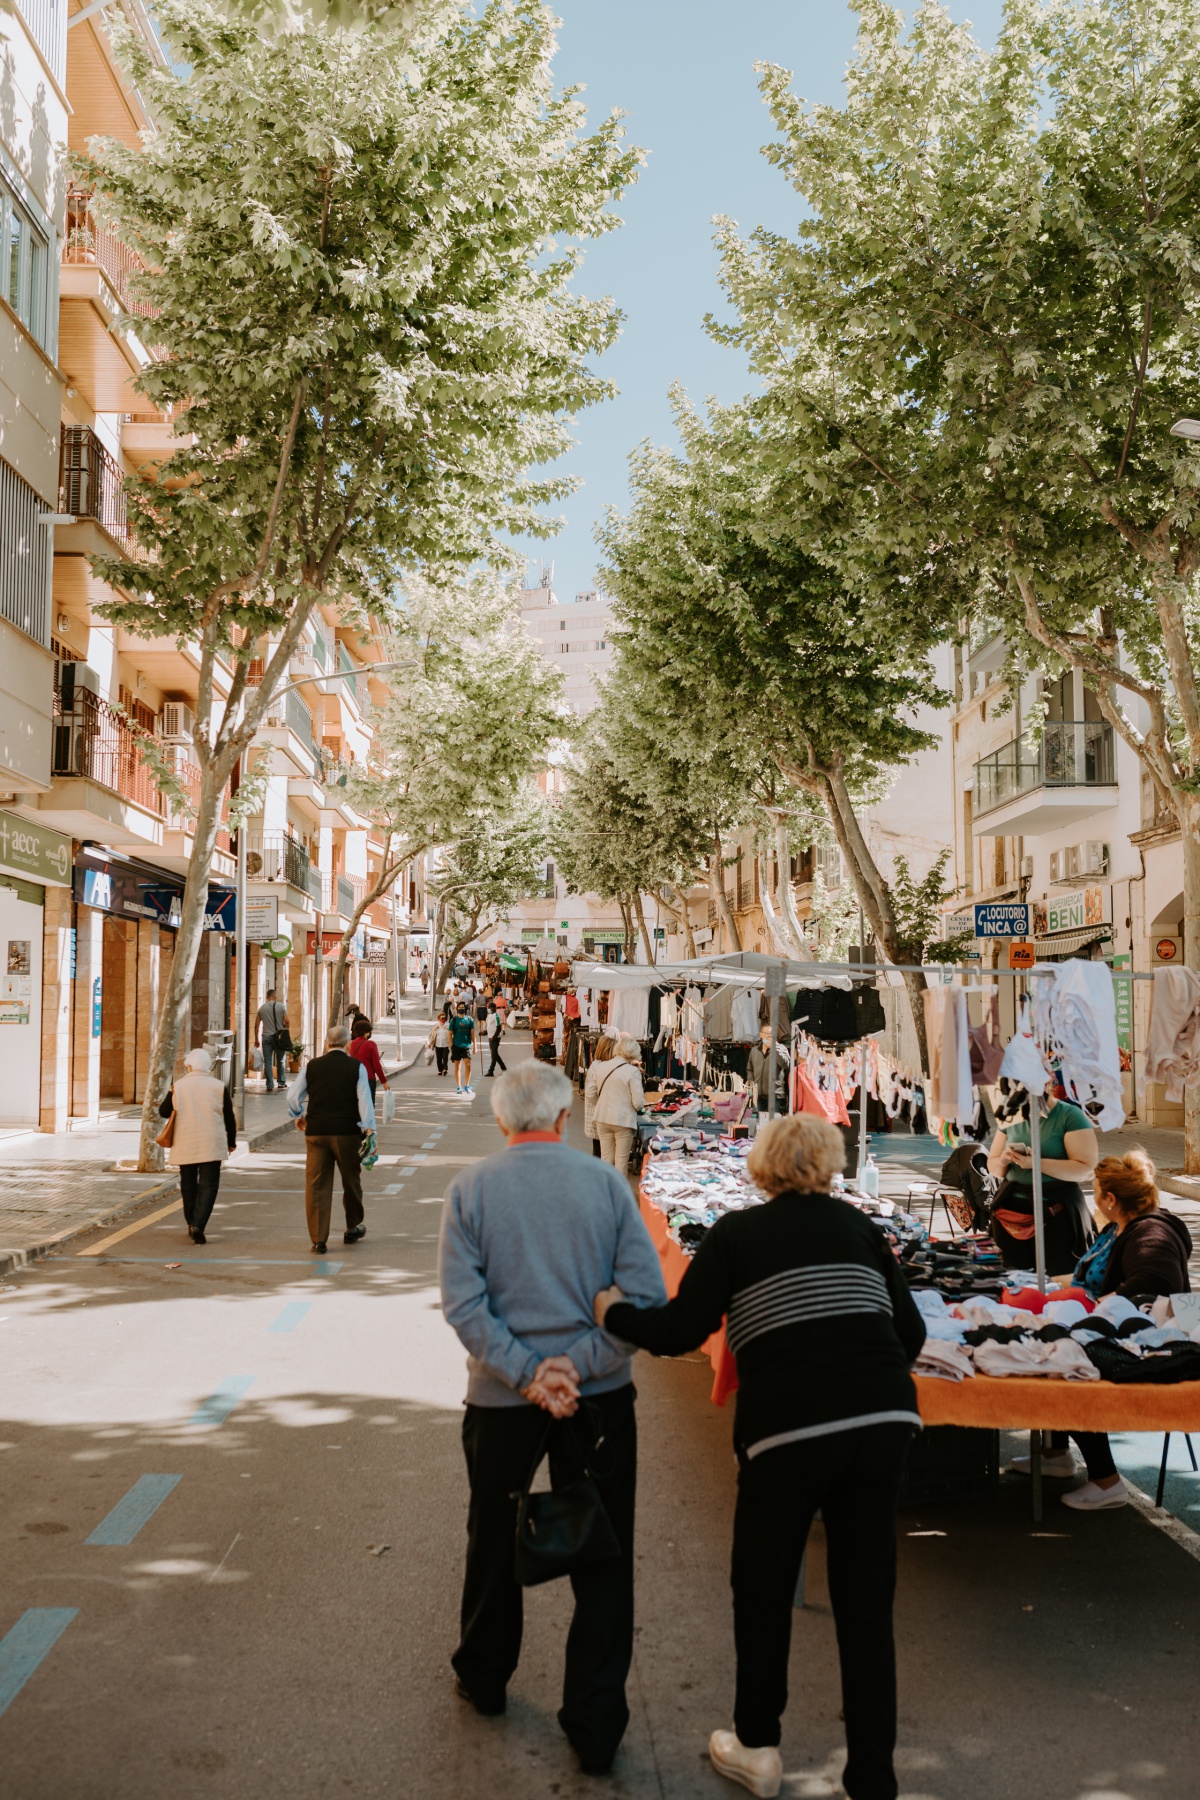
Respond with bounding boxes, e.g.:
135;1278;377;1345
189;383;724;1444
288;1024;374;1256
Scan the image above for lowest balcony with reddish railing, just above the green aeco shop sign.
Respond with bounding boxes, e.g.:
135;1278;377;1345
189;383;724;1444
41;689;167;848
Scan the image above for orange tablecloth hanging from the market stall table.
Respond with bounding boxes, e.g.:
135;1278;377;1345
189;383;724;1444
639;1195;1200;1431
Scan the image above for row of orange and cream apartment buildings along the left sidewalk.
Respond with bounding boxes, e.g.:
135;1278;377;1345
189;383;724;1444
0;0;408;1130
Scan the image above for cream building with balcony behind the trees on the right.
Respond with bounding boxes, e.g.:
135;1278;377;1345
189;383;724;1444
946;623;1184;1125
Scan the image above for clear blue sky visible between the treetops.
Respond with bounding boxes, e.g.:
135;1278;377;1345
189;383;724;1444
514;0;1000;599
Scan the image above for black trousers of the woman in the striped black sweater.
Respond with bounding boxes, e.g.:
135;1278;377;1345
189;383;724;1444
732;1424;914;1800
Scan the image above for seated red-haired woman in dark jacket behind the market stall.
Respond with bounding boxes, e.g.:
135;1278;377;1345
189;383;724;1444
1013;1150;1191;1512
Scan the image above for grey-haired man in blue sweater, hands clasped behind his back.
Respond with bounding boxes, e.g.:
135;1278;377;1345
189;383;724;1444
439;1062;666;1775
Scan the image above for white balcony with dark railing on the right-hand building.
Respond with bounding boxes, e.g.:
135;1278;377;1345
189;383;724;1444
972;720;1117;837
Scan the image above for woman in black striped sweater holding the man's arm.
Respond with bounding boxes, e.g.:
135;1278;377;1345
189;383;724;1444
596;1112;925;1800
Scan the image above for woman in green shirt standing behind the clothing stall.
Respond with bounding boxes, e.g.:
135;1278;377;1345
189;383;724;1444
988;1093;1099;1274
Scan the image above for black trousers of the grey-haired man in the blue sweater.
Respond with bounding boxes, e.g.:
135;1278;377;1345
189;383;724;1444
452;1384;637;1764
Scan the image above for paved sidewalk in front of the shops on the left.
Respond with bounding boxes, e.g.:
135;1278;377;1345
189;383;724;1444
0;990;428;1276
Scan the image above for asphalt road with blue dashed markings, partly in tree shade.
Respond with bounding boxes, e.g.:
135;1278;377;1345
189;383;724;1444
0;1048;1200;1800
